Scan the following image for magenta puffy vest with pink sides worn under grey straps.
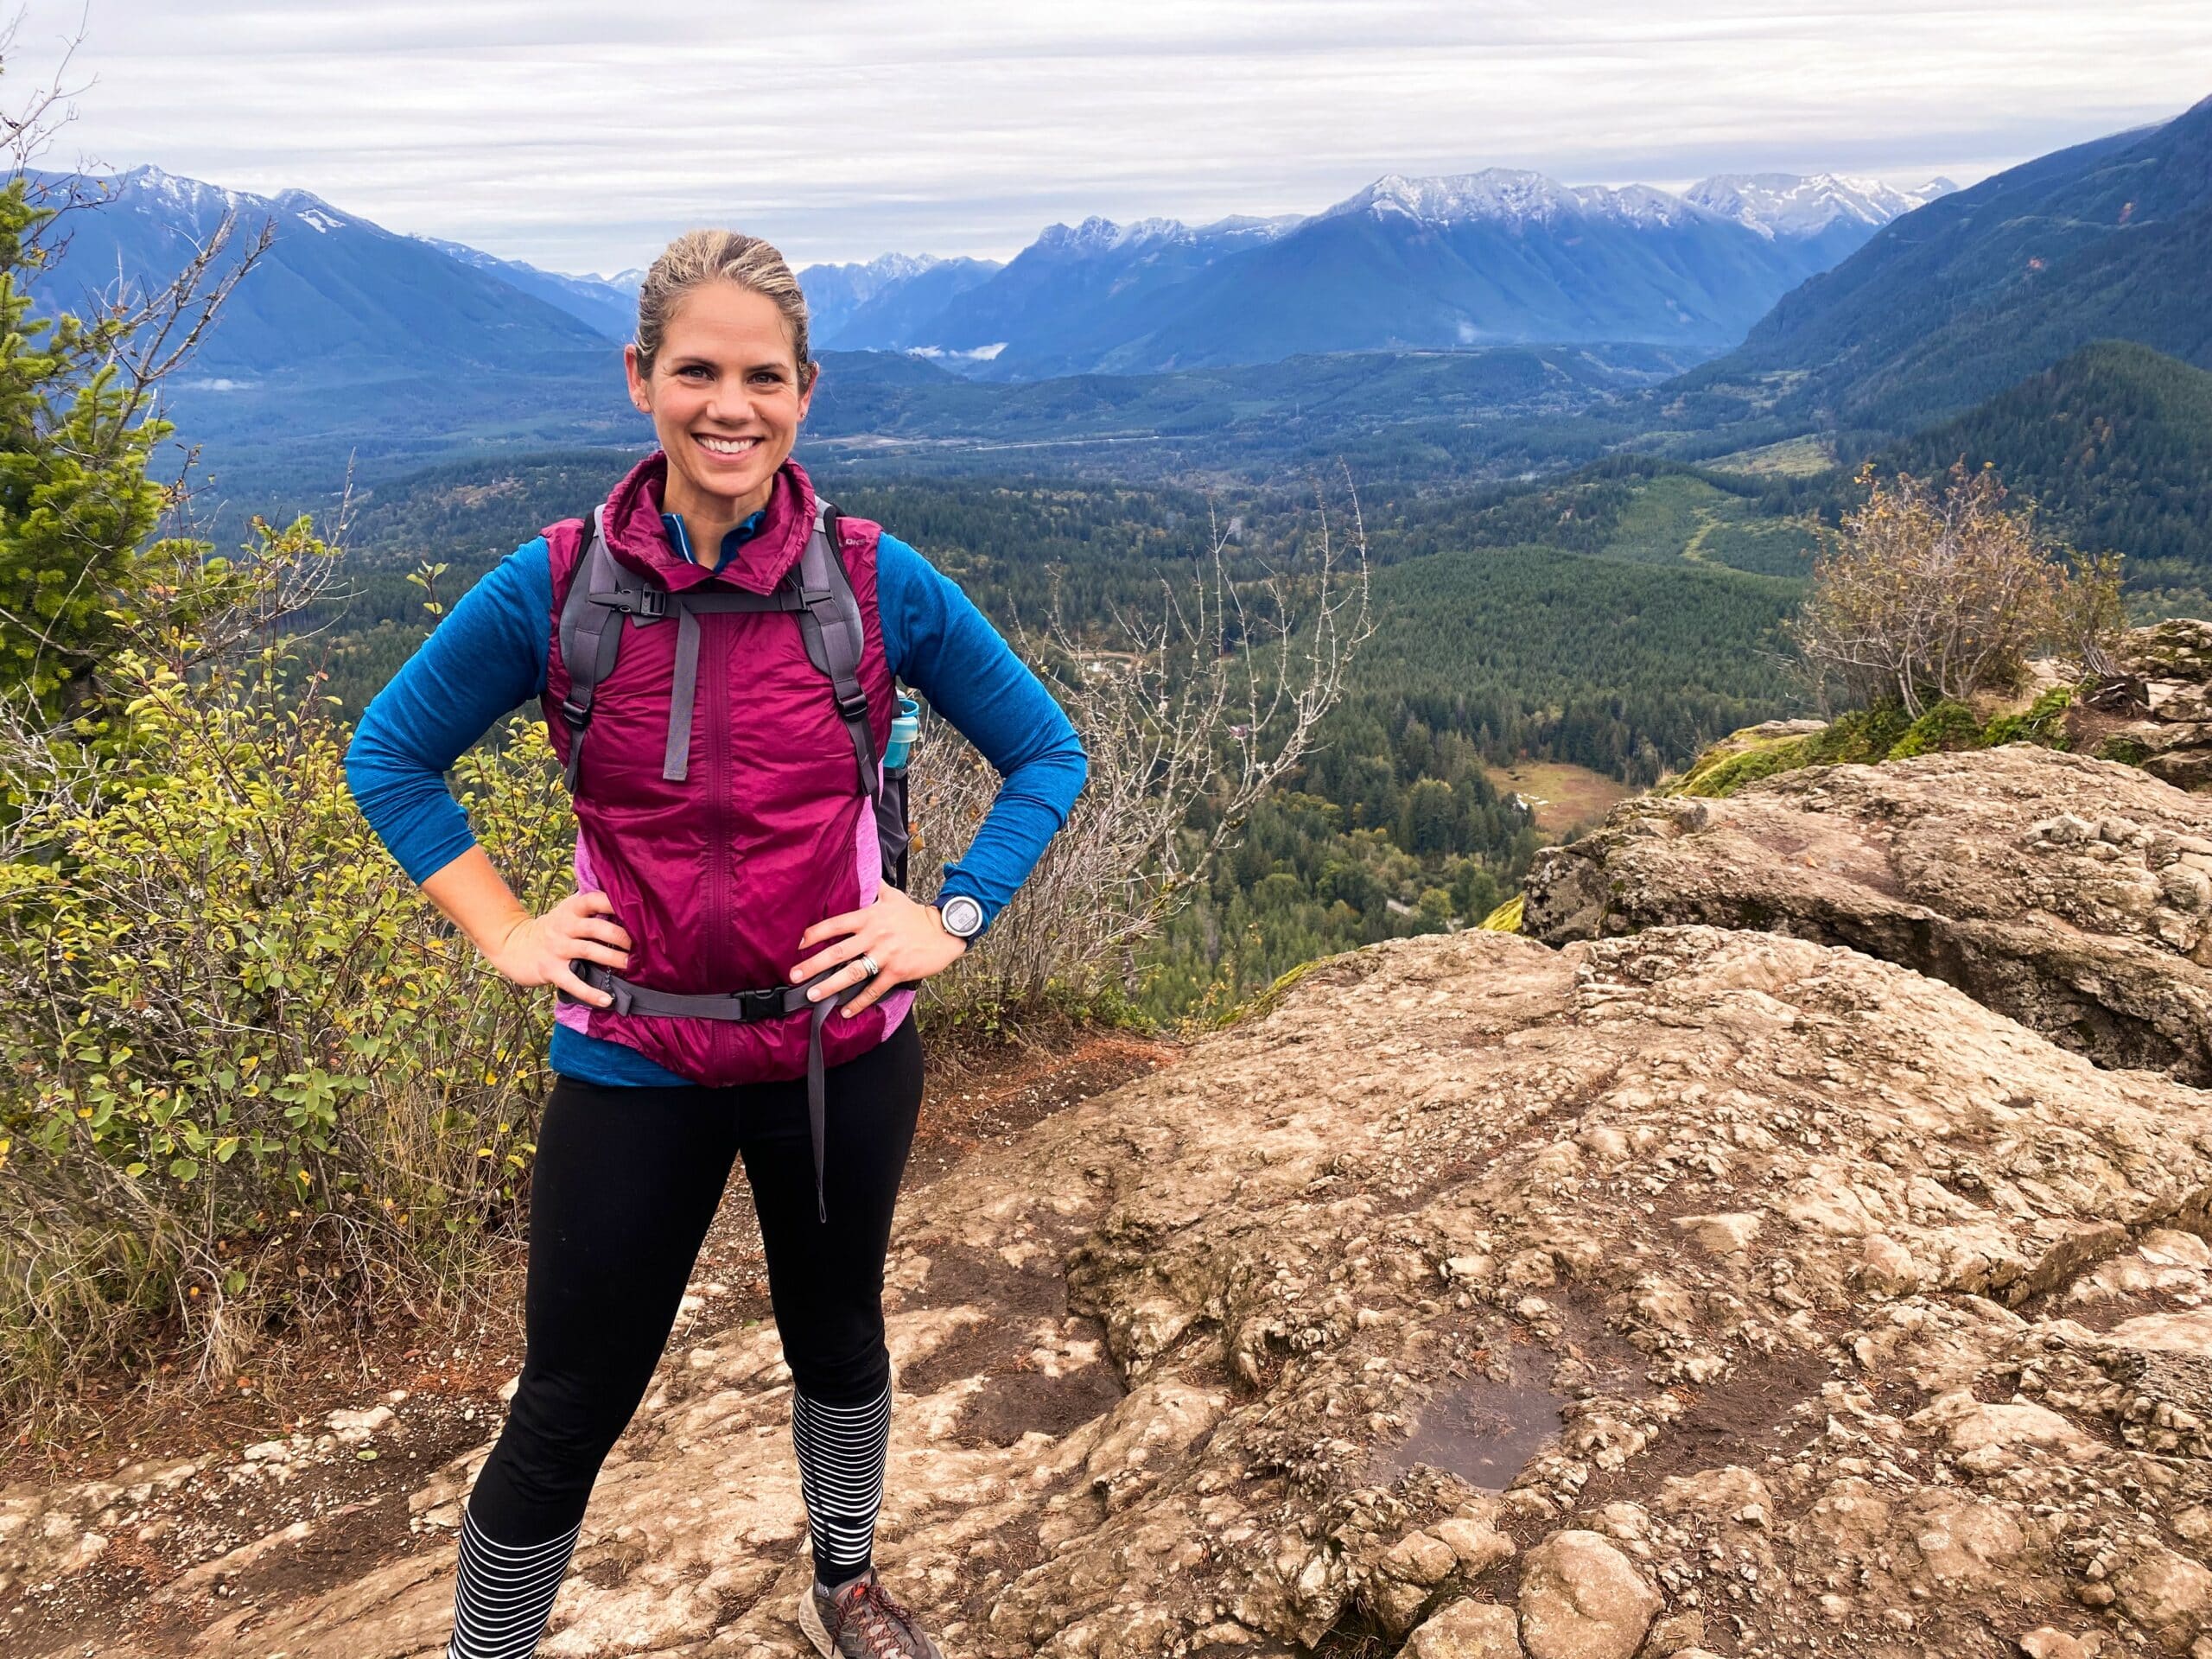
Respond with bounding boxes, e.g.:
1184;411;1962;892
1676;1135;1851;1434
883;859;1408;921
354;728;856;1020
544;454;913;1086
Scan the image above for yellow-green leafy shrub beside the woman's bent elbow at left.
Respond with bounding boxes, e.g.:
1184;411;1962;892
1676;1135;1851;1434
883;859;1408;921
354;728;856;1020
0;652;570;1407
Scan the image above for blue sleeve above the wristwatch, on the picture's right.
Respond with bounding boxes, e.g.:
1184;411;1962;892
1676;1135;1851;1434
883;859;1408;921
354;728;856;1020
876;533;1089;927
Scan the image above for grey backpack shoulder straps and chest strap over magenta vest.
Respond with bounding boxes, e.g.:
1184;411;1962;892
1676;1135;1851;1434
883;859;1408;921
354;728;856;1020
560;502;909;889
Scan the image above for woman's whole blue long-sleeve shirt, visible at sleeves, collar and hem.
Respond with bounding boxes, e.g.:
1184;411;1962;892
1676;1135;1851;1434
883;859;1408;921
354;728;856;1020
345;513;1086;1086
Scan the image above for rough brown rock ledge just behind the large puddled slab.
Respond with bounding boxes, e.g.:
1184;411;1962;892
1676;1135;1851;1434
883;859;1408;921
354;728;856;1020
1522;743;2212;1084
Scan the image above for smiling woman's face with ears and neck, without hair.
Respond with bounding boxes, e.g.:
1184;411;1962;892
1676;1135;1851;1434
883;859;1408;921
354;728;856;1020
621;281;814;522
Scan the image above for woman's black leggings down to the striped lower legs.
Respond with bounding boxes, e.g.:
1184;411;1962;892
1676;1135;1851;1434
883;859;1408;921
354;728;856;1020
469;1015;923;1546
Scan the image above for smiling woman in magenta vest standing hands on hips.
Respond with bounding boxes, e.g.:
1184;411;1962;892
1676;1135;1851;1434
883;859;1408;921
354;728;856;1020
347;230;1084;1659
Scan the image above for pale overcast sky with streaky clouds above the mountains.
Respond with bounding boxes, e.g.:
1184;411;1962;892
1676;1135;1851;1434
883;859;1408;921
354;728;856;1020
7;0;2212;270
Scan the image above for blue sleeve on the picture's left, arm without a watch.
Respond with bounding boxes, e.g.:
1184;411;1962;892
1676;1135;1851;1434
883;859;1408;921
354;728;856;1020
345;537;553;882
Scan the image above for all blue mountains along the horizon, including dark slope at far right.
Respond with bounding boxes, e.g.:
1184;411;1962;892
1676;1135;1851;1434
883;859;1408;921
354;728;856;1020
38;99;2212;493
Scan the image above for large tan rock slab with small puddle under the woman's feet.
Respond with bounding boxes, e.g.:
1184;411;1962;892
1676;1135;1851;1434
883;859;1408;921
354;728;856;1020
39;925;2212;1659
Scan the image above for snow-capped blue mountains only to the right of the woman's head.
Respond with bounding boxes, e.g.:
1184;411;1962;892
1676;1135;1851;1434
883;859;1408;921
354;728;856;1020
801;168;1951;380
